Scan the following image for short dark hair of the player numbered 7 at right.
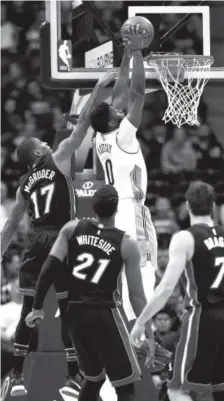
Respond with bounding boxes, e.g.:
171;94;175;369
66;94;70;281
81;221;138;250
185;181;215;216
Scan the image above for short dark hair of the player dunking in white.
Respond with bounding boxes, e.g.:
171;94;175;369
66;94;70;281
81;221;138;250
91;102;110;134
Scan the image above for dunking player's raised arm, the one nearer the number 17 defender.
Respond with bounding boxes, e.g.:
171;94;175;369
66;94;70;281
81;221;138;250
112;39;132;111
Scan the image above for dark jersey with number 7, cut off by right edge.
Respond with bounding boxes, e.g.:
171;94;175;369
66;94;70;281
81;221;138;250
183;224;224;306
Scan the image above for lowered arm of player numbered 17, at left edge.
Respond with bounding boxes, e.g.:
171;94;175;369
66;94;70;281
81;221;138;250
1;188;26;255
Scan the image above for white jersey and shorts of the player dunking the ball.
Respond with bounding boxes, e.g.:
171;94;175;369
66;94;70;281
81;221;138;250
96;118;155;320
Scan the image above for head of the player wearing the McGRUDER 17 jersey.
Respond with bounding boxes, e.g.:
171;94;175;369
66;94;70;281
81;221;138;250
17;137;52;167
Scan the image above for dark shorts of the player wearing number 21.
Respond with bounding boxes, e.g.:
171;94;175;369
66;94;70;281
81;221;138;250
68;303;141;387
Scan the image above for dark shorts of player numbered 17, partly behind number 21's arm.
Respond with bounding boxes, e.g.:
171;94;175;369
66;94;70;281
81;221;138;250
19;229;68;299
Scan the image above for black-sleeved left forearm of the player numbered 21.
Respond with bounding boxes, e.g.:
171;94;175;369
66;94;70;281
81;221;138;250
33;256;58;309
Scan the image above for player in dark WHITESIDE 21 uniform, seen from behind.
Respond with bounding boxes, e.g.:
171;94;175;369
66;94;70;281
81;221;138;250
26;185;154;401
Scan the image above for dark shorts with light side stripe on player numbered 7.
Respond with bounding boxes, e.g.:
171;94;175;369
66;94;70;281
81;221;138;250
169;305;224;392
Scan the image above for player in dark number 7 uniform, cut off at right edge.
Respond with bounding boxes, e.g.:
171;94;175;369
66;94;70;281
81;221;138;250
131;182;224;401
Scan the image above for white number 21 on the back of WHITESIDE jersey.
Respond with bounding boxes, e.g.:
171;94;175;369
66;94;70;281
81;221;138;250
72;253;110;284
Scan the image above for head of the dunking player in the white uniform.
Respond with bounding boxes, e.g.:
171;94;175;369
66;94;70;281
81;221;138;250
91;102;125;134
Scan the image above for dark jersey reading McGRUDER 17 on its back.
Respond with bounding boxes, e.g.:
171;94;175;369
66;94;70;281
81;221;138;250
20;154;75;229
